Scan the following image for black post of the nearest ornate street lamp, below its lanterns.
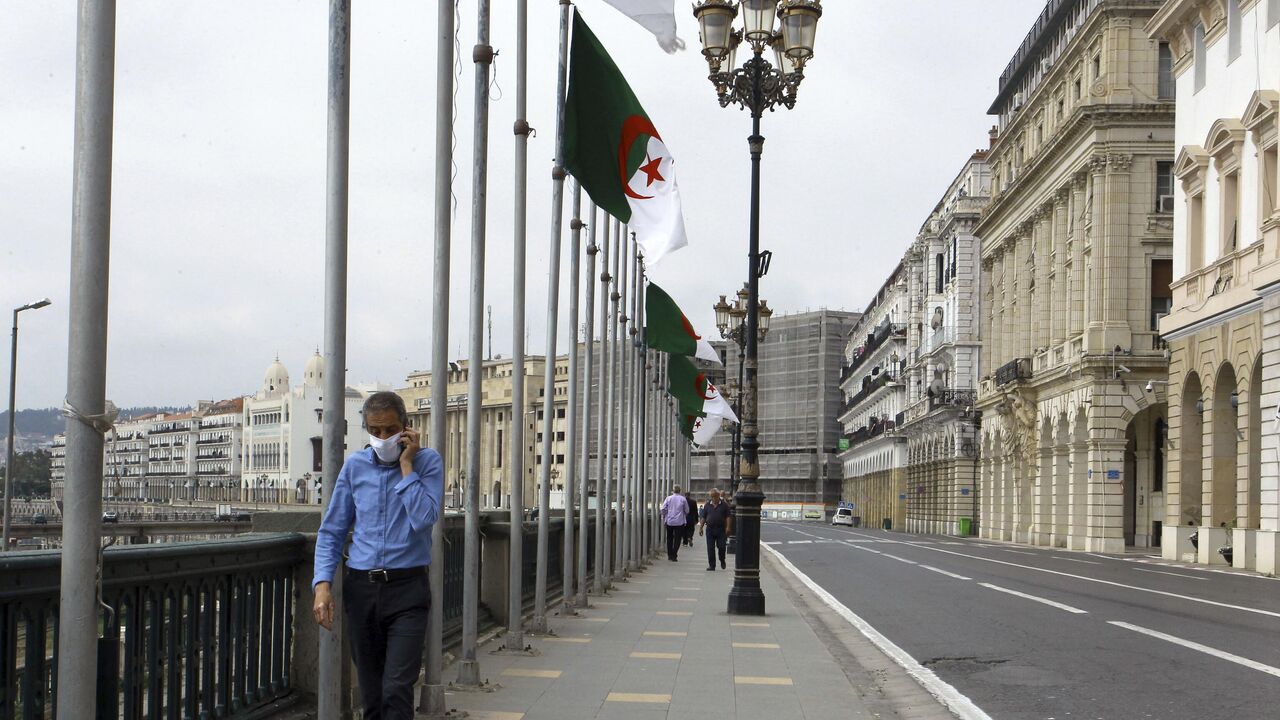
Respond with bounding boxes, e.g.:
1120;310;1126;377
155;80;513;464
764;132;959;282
728;94;764;615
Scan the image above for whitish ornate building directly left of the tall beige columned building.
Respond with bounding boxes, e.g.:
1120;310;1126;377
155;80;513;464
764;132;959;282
901;151;991;534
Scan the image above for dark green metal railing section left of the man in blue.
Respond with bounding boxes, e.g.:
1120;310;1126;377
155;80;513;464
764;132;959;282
0;533;306;720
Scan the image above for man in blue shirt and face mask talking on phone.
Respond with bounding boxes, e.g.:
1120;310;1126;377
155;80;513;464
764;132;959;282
311;392;444;720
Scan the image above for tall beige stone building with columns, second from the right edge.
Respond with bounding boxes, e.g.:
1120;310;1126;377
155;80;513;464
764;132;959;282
975;0;1174;552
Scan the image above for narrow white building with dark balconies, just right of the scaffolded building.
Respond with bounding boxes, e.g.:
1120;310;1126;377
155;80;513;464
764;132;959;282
837;264;910;529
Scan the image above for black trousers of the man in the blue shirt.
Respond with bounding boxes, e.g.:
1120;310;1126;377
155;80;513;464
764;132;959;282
342;569;431;720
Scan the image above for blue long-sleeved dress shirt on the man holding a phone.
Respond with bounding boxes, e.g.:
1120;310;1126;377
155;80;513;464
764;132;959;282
311;447;444;587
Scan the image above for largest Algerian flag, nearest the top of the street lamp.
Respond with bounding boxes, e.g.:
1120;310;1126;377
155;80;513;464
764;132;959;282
564;12;689;266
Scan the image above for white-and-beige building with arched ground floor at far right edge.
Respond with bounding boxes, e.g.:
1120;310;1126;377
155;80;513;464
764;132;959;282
1147;0;1280;574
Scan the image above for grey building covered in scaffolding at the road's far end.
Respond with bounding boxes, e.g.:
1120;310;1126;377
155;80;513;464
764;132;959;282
690;310;859;518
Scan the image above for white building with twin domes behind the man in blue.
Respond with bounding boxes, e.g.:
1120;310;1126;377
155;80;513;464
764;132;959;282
241;352;366;502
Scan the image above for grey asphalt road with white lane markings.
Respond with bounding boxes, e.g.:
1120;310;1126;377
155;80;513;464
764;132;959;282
763;521;1280;720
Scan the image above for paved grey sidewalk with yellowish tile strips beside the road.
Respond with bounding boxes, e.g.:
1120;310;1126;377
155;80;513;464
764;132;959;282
445;538;870;720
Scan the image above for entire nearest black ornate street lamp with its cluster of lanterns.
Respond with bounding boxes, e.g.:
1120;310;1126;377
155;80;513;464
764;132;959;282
694;0;822;615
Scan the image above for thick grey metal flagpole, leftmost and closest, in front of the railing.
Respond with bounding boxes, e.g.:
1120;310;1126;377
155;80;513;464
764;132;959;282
58;0;115;719
